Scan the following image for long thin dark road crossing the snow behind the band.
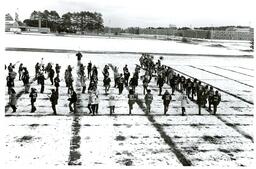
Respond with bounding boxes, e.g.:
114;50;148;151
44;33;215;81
5;47;253;58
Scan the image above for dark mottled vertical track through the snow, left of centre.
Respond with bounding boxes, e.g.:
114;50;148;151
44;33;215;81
68;59;82;165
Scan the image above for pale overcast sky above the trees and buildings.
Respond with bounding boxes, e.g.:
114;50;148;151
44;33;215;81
4;0;255;28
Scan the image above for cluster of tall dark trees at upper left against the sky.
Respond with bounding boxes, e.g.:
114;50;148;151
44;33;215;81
23;10;104;33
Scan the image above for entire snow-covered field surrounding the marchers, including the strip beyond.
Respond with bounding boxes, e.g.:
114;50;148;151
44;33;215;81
3;34;255;167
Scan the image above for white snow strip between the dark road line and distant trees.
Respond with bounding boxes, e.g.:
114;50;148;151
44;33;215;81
4;33;252;55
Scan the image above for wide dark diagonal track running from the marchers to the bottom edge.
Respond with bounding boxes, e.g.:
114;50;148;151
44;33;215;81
109;64;192;166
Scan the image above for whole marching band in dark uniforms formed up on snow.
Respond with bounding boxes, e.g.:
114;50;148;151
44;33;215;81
5;52;221;115
